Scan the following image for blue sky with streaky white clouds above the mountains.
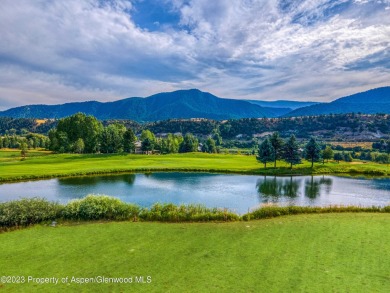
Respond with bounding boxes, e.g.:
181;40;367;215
0;0;390;110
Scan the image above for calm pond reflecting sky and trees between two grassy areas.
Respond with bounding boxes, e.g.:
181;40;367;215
0;172;390;214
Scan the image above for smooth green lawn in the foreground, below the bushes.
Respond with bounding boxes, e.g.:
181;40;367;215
0;213;390;292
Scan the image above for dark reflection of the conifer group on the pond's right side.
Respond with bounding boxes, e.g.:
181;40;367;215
256;176;333;202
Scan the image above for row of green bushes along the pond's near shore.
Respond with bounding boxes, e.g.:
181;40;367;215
0;195;390;230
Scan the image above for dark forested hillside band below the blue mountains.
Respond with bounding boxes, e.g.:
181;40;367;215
0;114;390;141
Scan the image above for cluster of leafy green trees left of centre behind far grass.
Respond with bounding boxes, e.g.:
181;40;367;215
48;113;206;153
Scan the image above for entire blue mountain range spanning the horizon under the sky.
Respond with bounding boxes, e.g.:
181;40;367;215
0;87;390;122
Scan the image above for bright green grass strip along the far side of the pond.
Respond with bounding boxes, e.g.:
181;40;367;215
0;150;390;182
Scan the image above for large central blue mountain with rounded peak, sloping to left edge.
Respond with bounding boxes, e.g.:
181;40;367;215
0;89;291;122
